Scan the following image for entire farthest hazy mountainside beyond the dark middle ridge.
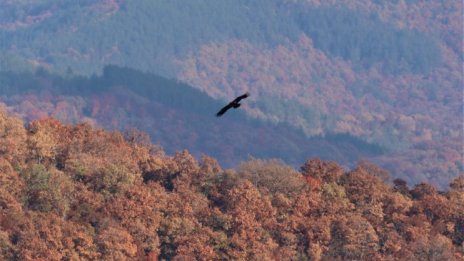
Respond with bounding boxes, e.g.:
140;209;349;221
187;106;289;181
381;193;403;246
0;0;464;185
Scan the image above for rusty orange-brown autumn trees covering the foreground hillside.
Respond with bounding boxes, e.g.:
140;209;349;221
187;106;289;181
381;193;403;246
0;107;464;260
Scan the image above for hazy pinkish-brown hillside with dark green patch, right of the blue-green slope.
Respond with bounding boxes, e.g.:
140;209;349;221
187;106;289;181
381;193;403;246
176;0;464;187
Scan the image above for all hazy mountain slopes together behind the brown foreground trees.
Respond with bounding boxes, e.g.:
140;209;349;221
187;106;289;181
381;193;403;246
0;0;464;186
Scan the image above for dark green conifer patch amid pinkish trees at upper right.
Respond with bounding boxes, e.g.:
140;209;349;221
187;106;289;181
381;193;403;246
298;7;441;74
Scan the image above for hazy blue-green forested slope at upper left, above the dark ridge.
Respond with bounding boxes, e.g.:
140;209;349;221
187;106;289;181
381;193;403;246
0;0;297;75
